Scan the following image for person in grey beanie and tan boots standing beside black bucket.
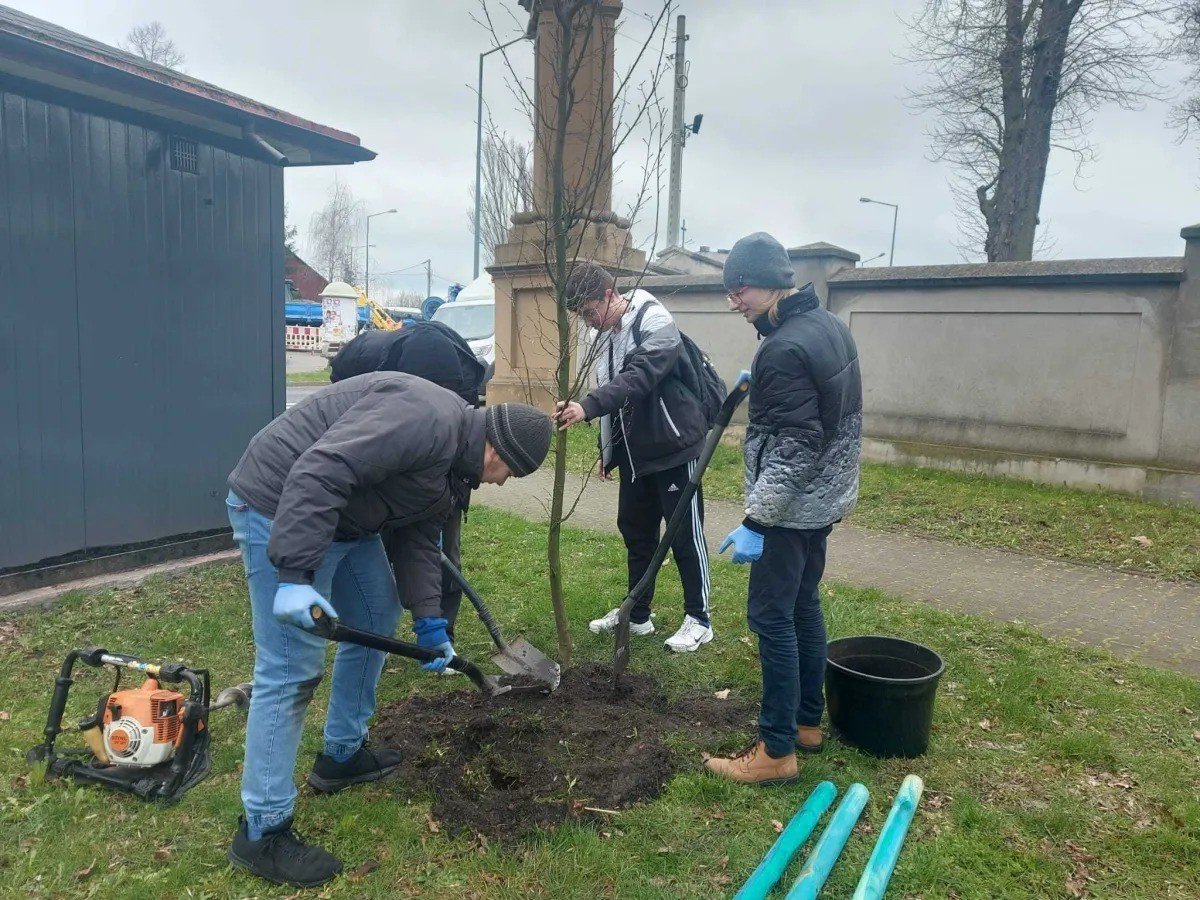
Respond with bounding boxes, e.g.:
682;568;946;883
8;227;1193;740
707;232;863;784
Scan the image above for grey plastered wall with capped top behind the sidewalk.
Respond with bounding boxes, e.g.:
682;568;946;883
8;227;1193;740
628;227;1200;503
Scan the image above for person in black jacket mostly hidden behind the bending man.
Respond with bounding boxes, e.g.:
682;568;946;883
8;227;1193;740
329;322;485;643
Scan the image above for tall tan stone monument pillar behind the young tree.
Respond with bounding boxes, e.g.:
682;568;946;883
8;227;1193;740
487;0;646;410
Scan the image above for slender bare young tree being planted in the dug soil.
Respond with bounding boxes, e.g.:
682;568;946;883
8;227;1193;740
481;0;674;666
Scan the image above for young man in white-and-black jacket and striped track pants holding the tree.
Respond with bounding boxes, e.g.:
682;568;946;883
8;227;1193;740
556;263;713;653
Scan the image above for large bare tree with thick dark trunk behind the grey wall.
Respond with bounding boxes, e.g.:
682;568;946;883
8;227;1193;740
908;0;1178;262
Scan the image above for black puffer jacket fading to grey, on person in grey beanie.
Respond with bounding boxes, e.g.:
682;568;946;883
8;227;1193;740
745;284;863;532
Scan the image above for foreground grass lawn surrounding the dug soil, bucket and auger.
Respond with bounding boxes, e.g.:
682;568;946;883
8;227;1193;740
0;509;1200;900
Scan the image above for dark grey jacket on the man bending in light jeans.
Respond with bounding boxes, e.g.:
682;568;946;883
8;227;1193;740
229;372;485;617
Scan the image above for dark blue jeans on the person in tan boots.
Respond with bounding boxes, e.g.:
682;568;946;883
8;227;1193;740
746;526;833;756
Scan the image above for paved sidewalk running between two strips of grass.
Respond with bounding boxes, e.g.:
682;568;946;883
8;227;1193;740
476;472;1200;677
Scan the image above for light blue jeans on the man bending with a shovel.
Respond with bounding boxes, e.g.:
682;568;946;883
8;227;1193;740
226;492;402;839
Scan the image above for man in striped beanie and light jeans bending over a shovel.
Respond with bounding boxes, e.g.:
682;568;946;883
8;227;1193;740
226;372;552;887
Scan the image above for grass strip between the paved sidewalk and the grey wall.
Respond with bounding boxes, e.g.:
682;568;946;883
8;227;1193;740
559;427;1200;580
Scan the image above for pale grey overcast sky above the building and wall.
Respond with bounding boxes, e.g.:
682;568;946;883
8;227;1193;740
18;0;1200;293
